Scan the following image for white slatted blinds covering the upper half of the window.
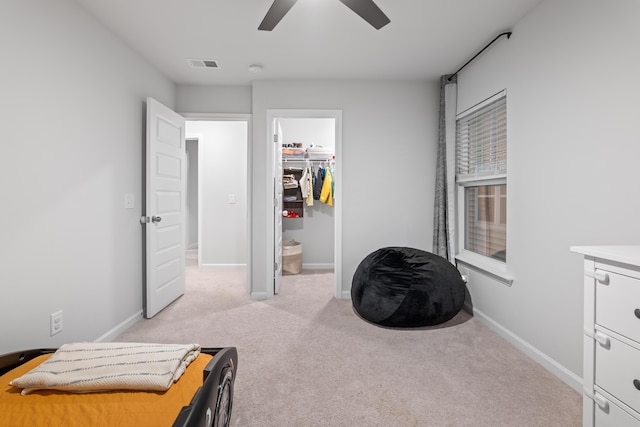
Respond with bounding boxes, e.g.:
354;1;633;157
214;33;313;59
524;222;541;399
456;92;507;182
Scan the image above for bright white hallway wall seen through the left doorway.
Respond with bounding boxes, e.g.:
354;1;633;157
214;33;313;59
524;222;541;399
186;121;248;266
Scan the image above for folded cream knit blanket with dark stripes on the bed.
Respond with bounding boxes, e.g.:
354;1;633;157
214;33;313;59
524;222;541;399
10;343;200;395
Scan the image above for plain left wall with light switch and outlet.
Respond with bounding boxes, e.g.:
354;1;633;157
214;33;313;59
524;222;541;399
0;0;175;353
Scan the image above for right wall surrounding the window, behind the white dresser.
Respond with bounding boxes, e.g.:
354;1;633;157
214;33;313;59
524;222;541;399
458;0;640;388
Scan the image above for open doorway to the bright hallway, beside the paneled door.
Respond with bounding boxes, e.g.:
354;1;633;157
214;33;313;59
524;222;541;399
185;115;250;289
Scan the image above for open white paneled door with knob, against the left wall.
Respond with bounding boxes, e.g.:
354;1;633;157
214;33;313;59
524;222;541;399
143;98;186;318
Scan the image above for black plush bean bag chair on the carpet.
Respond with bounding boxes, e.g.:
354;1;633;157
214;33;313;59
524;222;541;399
351;247;465;328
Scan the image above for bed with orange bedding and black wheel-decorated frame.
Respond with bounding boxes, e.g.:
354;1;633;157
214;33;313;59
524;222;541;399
0;347;238;427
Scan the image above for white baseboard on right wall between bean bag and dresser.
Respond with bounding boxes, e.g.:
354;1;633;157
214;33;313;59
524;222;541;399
472;307;582;394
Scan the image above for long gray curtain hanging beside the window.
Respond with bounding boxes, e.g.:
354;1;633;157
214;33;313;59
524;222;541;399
433;75;458;264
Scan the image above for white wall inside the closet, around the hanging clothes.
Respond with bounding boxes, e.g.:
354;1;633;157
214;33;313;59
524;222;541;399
279;118;336;268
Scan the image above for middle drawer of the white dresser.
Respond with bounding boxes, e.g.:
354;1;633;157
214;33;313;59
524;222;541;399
595;332;640;412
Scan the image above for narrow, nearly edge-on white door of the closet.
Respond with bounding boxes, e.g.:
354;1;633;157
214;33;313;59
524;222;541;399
273;119;283;294
